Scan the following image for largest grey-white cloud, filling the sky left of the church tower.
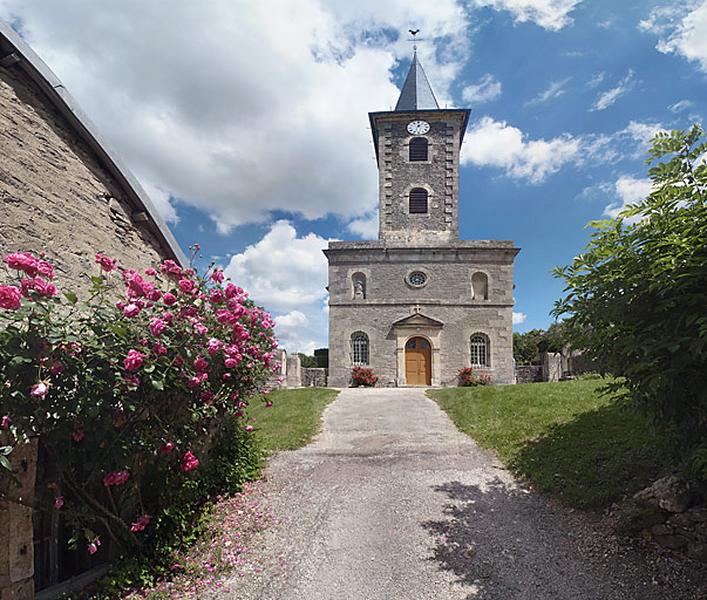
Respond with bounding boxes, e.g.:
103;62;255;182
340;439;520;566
0;0;469;233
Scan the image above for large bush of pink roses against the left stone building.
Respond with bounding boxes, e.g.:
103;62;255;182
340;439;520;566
0;246;279;553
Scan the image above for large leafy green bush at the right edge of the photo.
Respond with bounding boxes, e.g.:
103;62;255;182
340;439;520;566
554;125;707;438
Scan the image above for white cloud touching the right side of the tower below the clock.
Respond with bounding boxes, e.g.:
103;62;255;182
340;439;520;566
461;117;582;183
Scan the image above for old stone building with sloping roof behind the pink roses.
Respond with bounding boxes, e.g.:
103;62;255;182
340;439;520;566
0;21;185;600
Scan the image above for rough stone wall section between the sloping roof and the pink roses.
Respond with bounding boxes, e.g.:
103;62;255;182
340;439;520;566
0;69;167;287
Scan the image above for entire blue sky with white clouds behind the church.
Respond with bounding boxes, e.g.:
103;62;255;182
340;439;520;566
0;0;707;352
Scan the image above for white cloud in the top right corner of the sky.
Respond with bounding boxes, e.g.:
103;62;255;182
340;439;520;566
639;0;707;71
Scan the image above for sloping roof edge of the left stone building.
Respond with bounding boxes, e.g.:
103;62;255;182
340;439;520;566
0;20;188;265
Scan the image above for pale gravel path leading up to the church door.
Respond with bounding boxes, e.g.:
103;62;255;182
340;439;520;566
227;389;707;600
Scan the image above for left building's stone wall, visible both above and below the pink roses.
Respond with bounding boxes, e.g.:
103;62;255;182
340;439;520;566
0;58;176;600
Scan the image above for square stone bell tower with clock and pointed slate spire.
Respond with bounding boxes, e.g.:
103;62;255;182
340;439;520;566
368;52;470;246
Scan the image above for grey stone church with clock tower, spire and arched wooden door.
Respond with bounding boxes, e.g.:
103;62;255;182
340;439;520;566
324;55;519;387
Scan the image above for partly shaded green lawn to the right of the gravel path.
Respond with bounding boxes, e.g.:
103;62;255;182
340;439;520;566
428;379;680;509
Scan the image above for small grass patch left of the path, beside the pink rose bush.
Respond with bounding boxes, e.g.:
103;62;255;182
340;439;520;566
248;388;338;454
